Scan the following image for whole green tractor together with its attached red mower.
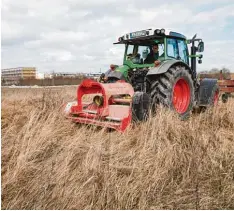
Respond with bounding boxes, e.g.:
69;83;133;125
65;29;219;131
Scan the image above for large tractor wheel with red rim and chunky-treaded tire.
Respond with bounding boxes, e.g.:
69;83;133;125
151;66;195;118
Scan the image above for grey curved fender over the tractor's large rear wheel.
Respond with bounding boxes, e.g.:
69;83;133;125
146;59;191;76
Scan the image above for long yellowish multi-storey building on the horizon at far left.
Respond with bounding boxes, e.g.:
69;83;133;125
1;67;36;85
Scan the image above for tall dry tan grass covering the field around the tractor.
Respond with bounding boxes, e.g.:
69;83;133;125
2;88;234;209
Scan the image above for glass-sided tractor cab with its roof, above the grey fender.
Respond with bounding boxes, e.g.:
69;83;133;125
114;29;189;67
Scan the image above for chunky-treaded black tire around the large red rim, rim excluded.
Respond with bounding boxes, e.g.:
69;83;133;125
150;66;195;118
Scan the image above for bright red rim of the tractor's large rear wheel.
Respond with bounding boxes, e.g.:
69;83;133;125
173;78;191;114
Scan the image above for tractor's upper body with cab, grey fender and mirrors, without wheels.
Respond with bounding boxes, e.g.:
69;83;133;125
109;29;204;85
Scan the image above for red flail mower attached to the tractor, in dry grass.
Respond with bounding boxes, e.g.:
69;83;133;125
64;79;134;131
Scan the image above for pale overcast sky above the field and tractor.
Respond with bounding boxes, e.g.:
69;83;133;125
1;0;234;72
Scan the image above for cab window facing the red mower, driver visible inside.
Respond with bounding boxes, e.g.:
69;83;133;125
125;40;164;64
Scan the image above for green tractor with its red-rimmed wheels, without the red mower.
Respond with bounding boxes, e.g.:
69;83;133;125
103;29;219;119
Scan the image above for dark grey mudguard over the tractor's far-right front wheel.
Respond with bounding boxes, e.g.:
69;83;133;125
198;78;218;106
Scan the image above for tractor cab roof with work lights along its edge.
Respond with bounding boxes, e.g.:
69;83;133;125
114;29;186;44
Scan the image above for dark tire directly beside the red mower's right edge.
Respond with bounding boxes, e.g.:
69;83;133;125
132;92;150;122
